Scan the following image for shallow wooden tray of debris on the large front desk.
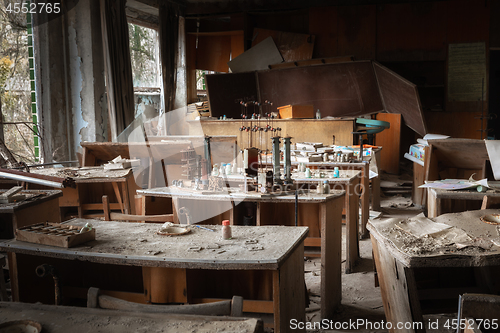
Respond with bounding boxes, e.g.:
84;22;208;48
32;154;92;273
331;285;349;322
16;222;95;248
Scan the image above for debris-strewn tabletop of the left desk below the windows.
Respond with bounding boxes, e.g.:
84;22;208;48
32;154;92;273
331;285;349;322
31;166;132;183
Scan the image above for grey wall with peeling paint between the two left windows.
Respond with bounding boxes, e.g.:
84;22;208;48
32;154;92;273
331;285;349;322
35;0;108;162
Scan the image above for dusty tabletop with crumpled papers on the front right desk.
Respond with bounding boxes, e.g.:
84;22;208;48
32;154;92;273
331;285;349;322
367;209;500;267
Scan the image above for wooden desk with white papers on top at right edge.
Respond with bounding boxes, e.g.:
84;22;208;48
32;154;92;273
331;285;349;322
427;188;500;217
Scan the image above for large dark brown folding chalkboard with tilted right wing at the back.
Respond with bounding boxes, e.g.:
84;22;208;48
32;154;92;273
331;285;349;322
206;60;427;139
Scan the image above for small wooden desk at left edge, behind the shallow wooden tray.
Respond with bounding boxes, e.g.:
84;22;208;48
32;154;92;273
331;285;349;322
0;190;62;239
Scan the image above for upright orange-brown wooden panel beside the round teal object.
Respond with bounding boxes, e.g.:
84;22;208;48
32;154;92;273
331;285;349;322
375;113;401;175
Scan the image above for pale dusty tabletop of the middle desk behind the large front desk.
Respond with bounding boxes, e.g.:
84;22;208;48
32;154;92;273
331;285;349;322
137;186;345;203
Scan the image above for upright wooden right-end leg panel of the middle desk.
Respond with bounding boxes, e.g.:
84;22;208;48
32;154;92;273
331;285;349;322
320;198;343;319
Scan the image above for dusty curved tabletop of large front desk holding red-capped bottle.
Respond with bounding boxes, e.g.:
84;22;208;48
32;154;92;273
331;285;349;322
0;219;309;269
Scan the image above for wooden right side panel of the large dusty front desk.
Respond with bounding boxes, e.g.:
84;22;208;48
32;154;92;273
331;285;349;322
273;243;306;333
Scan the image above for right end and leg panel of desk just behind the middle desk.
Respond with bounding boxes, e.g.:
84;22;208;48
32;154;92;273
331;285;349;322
292;170;362;274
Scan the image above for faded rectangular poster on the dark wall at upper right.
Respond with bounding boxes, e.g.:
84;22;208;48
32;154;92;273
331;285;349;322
448;43;487;102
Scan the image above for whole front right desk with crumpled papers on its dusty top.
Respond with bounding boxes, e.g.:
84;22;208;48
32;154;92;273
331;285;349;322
368;210;500;333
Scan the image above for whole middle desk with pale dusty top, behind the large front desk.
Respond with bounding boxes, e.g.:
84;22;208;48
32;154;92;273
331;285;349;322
137;186;346;318
